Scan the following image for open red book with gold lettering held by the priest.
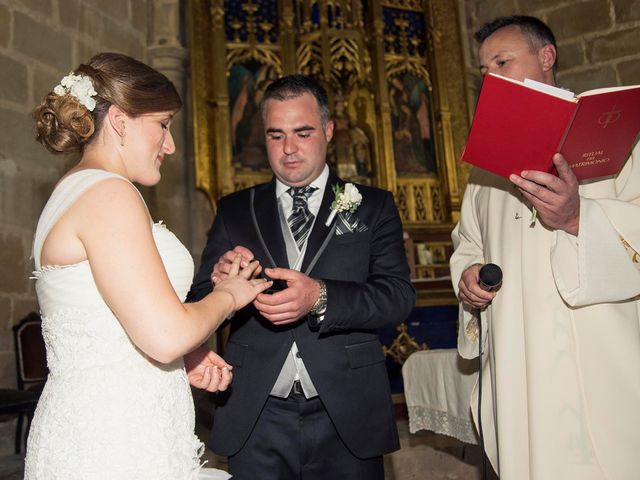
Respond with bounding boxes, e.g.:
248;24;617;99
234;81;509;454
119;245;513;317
461;74;640;180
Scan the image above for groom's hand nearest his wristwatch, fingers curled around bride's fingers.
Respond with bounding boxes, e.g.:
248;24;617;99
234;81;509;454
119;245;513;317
253;268;320;325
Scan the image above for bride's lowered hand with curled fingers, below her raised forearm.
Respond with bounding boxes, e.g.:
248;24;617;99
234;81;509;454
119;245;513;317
184;346;233;392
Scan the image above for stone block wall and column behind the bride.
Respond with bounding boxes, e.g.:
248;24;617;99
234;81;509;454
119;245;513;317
0;0;211;394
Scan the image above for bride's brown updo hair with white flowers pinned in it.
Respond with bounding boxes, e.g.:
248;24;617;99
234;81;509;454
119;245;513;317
33;53;182;153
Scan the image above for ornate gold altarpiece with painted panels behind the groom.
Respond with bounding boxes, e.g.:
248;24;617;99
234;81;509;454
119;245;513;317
189;0;468;305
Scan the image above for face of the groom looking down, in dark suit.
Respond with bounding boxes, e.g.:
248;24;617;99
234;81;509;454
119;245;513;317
264;93;333;187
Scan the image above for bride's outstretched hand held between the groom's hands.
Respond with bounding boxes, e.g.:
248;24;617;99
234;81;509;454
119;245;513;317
214;255;273;312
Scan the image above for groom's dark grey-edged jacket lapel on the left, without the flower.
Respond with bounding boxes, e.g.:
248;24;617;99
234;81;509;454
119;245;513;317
251;179;289;268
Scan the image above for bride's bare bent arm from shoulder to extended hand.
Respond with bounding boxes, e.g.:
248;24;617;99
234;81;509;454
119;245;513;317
70;179;266;363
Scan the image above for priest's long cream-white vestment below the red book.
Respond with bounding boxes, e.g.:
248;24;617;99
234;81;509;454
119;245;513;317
451;144;640;480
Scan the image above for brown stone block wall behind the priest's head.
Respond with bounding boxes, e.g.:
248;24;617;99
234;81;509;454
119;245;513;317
459;0;640;114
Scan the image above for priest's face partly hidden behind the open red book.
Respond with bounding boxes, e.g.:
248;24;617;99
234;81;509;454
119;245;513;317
478;25;556;85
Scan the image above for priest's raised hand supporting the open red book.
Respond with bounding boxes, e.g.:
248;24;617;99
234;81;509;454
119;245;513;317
509;153;580;236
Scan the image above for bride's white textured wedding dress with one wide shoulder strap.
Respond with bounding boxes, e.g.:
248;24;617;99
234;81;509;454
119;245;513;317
25;170;227;480
